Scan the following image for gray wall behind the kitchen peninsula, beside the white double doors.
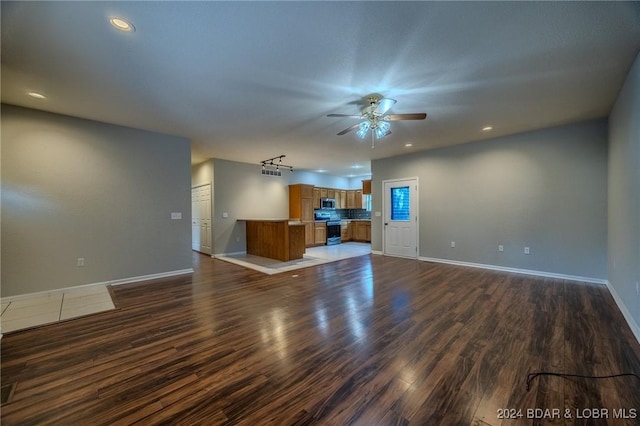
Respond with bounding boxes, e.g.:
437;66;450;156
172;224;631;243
191;158;363;254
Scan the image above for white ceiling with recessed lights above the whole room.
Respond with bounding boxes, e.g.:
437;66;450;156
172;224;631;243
1;1;640;176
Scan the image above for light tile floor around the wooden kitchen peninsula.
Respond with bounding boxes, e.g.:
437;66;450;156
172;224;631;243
216;242;371;275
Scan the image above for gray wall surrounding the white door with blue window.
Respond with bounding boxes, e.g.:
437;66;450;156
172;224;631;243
372;120;607;280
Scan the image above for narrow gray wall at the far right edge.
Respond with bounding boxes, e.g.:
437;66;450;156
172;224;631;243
609;50;640;330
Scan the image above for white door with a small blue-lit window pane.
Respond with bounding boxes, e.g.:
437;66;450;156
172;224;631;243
383;178;418;259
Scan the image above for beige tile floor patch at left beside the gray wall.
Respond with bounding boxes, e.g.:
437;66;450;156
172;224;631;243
0;286;115;333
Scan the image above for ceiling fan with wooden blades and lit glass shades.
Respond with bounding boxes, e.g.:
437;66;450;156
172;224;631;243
327;94;427;148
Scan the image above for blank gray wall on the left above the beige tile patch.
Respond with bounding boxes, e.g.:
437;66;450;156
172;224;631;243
1;104;191;296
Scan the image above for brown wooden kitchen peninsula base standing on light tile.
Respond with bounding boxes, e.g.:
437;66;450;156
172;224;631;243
240;219;305;262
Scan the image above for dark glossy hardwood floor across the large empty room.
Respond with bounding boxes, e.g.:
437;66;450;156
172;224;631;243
1;253;640;425
